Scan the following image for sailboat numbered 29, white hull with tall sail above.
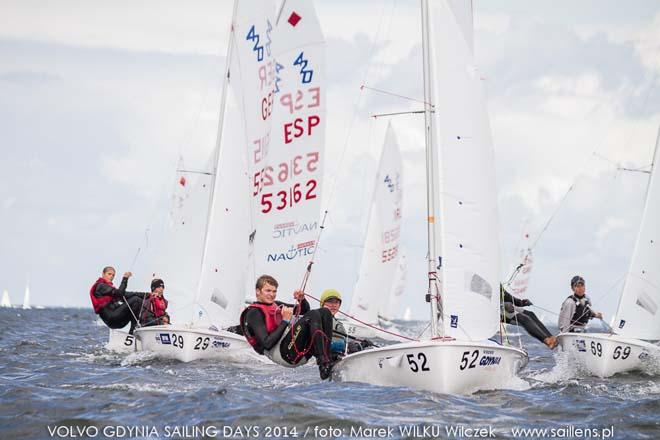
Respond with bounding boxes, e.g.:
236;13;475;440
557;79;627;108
130;0;275;362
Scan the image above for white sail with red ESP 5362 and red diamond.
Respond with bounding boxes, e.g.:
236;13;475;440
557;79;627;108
248;0;325;298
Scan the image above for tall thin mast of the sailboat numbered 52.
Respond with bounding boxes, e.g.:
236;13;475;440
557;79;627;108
421;0;444;338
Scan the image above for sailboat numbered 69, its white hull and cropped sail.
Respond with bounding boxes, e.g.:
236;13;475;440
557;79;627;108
557;130;660;377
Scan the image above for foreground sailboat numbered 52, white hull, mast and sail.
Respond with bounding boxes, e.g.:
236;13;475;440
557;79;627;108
333;0;528;393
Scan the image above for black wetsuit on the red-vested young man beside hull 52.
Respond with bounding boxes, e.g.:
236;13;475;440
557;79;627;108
244;299;332;365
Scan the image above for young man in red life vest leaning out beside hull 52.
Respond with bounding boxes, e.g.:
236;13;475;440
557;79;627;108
241;275;332;380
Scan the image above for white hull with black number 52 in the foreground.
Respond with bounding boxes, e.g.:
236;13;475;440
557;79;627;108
333;340;528;394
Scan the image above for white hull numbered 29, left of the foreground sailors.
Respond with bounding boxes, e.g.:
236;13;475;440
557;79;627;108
135;325;256;362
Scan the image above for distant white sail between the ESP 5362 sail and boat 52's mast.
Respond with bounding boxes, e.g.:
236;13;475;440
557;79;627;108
349;125;403;324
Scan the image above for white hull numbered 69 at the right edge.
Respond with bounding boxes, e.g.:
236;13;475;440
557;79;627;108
557;333;660;377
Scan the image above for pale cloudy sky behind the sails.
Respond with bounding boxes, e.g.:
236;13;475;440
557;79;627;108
0;0;660;320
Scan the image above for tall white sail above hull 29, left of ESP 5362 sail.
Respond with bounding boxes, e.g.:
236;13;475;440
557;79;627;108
197;0;275;326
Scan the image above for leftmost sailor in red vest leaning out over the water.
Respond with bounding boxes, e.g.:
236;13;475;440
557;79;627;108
89;266;148;334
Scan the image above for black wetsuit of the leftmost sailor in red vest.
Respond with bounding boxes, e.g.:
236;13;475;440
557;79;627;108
94;278;148;334
